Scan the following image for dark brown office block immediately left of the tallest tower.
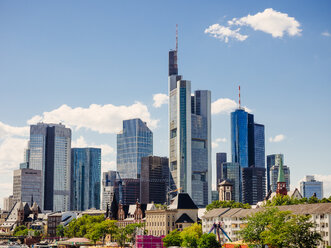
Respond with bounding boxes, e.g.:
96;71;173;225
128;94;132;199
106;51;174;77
140;156;169;204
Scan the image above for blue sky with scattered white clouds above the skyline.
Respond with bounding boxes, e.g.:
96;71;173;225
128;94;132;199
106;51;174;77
0;0;331;206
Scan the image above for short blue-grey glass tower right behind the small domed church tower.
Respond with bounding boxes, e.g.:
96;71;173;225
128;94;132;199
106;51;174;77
221;162;242;202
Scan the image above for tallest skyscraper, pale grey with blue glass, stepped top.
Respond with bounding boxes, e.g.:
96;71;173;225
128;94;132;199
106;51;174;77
168;37;212;207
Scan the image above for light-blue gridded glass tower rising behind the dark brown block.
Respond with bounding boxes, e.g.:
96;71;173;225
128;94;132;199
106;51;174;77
117;119;153;179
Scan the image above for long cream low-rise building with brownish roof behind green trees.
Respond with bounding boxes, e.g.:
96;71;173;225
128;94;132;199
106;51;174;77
202;203;331;248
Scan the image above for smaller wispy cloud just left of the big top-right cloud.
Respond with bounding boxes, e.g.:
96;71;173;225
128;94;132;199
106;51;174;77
205;24;248;43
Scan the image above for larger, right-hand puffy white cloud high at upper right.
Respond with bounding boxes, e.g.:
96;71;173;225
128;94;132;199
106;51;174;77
232;8;302;38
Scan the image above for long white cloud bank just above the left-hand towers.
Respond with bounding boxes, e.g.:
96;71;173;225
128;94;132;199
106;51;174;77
28;102;159;134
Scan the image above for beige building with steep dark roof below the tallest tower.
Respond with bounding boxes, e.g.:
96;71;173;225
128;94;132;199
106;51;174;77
145;193;198;236
